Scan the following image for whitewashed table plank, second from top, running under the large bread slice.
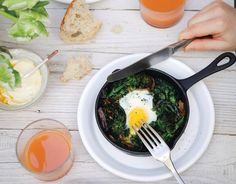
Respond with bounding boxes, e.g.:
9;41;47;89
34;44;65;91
0;10;206;53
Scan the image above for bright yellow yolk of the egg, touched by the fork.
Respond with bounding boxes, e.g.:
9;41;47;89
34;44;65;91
128;108;148;128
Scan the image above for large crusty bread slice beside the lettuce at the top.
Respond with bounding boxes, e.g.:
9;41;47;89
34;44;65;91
60;0;102;43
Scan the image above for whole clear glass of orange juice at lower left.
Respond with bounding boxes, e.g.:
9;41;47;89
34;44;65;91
16;119;73;181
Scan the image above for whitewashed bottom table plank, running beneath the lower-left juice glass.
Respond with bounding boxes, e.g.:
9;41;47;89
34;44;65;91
0;130;236;184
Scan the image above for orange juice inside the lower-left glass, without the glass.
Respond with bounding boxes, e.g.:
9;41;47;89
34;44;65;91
23;130;71;172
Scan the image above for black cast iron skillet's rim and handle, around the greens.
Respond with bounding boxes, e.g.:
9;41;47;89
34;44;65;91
95;52;236;156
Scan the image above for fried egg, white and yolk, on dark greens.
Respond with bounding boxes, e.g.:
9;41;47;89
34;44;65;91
119;90;157;134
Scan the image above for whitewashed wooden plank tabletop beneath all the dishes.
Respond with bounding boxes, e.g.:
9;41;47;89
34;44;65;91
0;0;236;184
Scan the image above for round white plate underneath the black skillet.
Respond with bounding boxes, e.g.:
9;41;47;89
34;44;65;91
78;54;215;181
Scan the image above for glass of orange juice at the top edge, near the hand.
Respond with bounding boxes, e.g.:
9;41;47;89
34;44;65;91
140;0;185;28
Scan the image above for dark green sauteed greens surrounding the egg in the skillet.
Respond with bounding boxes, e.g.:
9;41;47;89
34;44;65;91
97;73;186;152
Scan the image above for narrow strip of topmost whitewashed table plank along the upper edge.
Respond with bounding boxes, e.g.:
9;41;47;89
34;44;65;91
48;0;233;10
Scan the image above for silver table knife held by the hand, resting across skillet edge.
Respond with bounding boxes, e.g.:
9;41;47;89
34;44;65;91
107;39;194;82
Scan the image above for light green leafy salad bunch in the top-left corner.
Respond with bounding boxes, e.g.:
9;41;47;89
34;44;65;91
0;0;49;41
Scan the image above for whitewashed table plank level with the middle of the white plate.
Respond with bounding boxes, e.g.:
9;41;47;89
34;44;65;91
0;66;236;134
